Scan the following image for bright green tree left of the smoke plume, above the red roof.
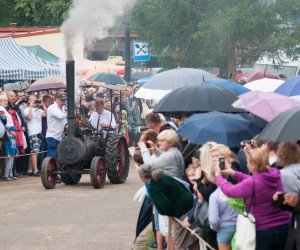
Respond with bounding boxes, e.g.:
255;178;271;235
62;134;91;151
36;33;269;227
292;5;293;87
15;0;72;26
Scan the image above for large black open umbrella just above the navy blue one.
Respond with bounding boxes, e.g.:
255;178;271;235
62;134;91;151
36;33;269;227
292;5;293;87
154;84;243;116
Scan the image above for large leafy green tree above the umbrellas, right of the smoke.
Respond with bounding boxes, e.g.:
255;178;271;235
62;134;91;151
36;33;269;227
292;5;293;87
133;0;300;74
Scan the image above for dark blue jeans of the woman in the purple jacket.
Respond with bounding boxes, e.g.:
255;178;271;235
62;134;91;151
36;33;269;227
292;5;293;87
256;224;289;250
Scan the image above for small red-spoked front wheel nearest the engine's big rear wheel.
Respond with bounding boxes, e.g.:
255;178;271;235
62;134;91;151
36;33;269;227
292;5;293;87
90;156;106;188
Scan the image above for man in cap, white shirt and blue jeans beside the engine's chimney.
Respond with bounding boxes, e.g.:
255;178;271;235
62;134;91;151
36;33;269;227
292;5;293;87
46;93;67;158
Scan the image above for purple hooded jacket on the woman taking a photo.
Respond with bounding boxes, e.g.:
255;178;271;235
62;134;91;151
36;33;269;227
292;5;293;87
216;168;290;231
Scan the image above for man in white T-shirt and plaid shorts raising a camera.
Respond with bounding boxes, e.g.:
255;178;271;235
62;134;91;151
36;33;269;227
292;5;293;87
24;95;47;176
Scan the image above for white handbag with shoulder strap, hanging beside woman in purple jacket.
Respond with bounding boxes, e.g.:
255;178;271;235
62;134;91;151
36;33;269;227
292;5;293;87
235;178;256;250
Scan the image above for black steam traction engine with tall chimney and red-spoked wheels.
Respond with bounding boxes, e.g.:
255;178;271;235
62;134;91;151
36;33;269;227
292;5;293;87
41;61;129;189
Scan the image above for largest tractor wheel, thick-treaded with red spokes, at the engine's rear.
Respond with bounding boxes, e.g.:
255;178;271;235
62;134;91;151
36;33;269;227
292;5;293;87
104;134;129;184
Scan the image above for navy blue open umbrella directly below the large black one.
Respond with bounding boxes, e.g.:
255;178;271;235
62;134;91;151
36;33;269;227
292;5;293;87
177;111;260;147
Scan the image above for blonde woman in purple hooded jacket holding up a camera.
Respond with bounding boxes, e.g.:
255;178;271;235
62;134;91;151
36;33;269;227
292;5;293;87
216;148;290;250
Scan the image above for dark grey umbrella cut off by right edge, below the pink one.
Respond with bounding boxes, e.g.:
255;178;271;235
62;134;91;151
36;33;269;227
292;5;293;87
259;108;300;142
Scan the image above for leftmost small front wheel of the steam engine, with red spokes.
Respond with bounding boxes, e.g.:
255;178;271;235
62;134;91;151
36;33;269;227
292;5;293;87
41;157;57;189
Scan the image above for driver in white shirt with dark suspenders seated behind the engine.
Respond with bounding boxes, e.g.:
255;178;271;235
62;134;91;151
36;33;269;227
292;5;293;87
89;100;116;134
